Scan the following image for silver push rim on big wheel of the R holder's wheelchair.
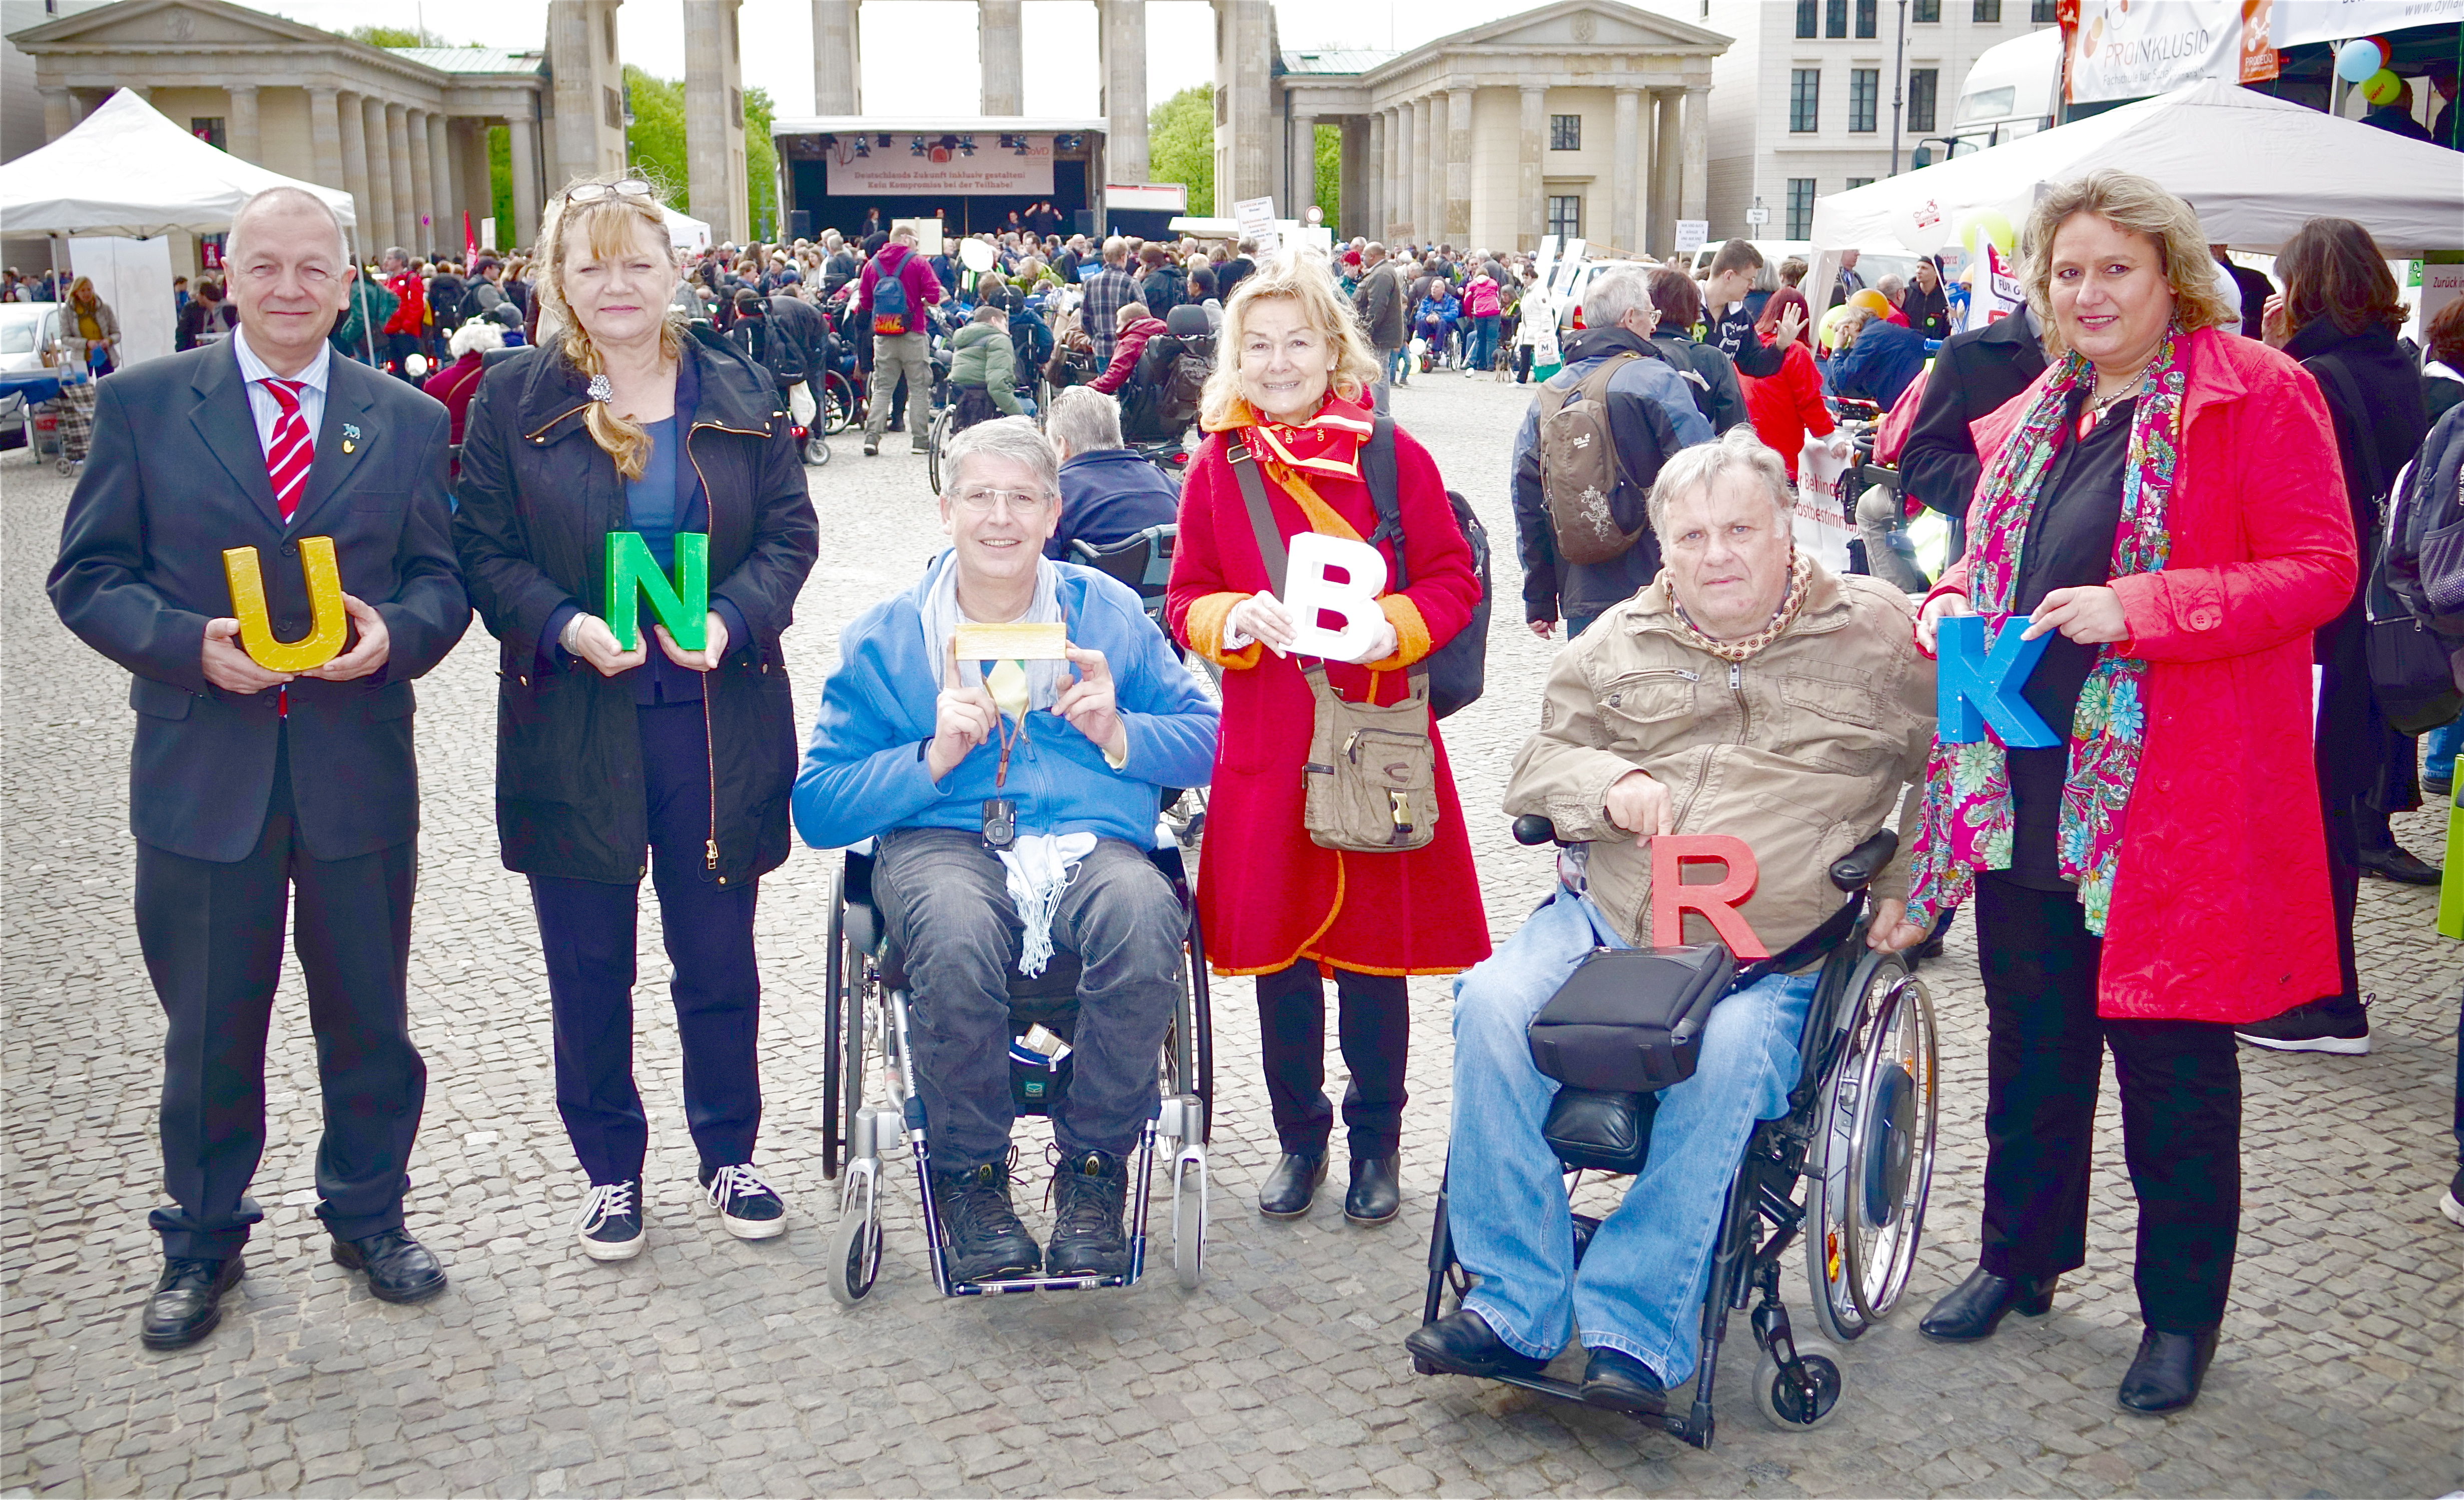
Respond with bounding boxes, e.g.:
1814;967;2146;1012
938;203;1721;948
1848;975;1939;1323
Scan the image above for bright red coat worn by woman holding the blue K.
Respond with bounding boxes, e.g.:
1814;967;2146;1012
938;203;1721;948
1937;328;2358;1025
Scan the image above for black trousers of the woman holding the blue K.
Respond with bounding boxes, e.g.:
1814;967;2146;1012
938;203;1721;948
1976;875;2242;1332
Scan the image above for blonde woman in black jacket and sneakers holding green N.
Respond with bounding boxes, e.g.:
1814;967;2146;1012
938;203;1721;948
453;180;821;1261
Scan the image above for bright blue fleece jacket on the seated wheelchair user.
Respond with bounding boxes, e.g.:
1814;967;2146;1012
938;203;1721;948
796;561;1217;850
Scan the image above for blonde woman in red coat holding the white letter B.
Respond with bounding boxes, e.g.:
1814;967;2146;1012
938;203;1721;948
1165;259;1488;1224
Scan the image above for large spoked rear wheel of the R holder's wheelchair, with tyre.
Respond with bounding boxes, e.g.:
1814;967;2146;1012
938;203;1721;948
1806;953;1934;1345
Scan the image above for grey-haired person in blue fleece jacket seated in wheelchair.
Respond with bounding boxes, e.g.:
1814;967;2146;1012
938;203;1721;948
794;416;1217;1283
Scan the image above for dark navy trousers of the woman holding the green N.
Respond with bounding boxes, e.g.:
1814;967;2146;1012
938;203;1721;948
530;702;762;1187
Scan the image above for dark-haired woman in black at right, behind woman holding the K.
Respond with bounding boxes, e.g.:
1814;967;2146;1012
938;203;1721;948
2240;219;2439;1054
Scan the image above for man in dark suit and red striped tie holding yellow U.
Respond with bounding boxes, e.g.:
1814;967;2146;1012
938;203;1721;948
49;187;470;1350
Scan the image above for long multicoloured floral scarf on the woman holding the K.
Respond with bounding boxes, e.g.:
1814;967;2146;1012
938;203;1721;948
1907;328;2188;936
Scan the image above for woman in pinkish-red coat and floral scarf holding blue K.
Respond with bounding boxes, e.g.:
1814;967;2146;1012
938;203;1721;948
1895;170;2355;1414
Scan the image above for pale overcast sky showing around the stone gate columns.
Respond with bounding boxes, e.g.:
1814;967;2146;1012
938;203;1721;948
260;0;1513;118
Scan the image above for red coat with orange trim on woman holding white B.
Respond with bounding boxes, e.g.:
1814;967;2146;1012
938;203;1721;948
1165;418;1488;975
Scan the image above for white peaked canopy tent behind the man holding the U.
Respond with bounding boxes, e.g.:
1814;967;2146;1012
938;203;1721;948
0;89;360;239
